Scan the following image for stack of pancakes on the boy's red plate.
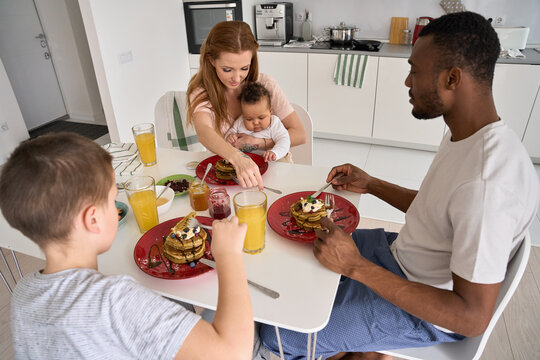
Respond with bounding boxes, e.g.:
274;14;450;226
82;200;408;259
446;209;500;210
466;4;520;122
163;212;208;264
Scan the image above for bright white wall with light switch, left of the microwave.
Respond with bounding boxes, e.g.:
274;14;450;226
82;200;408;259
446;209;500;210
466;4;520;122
79;0;189;142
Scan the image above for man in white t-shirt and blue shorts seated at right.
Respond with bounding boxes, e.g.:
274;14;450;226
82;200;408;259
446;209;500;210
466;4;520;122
261;12;539;360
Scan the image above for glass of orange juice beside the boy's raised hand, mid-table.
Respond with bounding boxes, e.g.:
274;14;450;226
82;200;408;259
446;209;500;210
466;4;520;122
233;190;266;254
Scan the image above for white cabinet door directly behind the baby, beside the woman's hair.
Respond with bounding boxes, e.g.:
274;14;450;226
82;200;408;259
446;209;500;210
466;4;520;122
257;51;308;109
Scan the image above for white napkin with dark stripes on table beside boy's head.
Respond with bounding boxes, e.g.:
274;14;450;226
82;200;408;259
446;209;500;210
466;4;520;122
103;143;143;183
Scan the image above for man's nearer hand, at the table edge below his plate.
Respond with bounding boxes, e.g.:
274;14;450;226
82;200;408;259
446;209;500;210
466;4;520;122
313;218;364;276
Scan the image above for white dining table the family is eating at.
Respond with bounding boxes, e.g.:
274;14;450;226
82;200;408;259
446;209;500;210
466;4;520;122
0;148;360;360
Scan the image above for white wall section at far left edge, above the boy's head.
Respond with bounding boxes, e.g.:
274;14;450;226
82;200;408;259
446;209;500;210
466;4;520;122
0;59;29;165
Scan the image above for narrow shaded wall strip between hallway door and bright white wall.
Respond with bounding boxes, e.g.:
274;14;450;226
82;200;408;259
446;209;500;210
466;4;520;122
35;0;105;124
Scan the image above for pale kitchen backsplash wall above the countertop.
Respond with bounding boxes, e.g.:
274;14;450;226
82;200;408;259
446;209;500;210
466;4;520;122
242;0;540;44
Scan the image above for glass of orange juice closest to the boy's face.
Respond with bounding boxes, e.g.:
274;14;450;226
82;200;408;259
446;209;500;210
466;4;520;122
124;176;159;232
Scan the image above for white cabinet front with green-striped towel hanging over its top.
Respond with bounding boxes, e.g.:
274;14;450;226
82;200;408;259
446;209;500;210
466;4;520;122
308;54;379;140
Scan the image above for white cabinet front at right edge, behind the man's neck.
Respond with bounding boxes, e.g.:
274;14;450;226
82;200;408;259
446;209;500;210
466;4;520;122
493;64;540;139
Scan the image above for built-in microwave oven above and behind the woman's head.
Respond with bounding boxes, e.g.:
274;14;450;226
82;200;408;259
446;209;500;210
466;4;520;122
183;0;242;54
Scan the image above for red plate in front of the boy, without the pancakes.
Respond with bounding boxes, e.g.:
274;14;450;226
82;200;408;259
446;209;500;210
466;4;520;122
133;216;214;280
